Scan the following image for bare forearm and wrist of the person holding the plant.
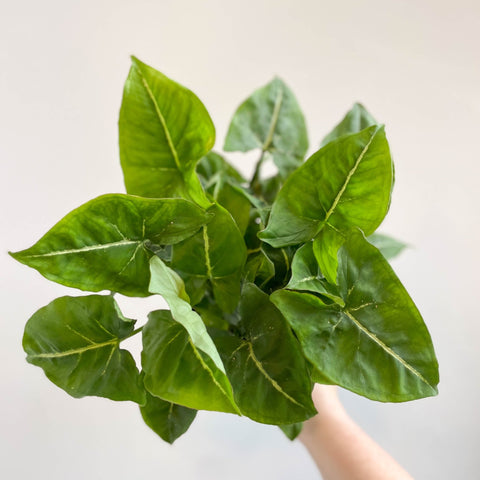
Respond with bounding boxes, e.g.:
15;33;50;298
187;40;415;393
298;385;413;480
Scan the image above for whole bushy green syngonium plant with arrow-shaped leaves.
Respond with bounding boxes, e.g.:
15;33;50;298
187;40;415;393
12;58;438;442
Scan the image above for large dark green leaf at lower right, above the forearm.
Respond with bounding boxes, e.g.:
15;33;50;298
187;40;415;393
271;231;438;402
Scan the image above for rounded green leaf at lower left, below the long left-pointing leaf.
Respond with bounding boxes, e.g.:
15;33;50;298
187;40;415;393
23;295;145;404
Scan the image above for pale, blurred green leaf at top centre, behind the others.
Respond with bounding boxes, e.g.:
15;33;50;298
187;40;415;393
224;78;308;177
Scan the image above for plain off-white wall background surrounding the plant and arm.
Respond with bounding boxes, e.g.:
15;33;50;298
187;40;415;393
0;0;480;480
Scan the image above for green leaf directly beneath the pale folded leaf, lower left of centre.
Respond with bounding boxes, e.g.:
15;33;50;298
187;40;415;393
142;310;240;414
